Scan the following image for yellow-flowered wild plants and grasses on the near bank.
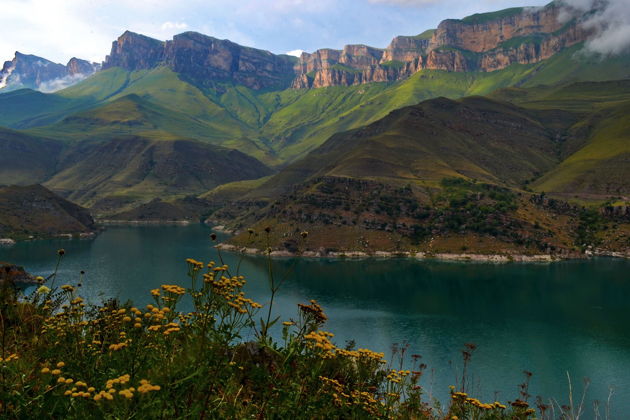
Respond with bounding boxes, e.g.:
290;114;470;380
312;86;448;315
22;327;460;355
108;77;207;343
0;248;608;420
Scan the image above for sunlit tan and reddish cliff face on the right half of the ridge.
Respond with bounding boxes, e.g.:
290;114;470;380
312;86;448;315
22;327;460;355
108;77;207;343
292;3;589;88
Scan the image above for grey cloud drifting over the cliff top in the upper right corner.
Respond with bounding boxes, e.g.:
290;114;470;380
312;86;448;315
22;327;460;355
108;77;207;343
561;0;630;55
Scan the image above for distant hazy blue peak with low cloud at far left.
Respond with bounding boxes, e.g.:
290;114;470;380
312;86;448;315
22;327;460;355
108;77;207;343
0;51;100;92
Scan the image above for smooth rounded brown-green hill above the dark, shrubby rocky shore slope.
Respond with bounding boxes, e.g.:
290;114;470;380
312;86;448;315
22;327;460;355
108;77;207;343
242;97;571;197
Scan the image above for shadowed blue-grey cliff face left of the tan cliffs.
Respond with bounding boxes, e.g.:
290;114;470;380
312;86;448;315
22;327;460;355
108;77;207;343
103;32;295;89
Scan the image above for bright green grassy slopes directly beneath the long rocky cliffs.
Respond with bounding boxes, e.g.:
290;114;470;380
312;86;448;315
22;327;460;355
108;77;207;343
0;45;630;165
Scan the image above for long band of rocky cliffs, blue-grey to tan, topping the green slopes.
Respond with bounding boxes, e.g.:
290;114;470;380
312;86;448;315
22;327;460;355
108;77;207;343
103;2;592;90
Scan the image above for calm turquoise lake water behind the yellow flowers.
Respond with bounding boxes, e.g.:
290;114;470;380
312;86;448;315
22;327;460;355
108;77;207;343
0;225;630;418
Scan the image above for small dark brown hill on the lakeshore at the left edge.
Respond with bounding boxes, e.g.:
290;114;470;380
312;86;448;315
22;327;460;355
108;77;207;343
0;185;95;239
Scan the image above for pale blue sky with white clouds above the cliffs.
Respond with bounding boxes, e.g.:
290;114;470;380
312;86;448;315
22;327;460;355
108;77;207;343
0;0;556;67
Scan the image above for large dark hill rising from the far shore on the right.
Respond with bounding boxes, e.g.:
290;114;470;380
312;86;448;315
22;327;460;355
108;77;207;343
211;80;630;255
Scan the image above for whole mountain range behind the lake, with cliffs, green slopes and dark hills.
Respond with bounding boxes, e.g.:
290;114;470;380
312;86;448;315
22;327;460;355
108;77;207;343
0;2;630;256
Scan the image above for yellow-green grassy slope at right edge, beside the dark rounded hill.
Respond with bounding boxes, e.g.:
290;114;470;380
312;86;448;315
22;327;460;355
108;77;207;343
494;80;630;200
